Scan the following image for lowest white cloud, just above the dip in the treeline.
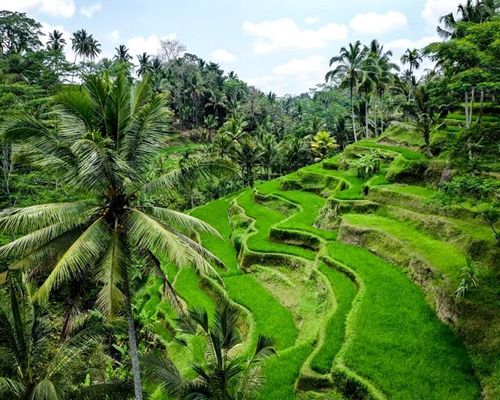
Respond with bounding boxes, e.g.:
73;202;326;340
247;55;328;96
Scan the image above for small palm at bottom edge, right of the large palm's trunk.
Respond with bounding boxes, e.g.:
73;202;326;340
142;303;275;400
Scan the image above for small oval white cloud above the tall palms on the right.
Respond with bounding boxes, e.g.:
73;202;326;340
349;11;408;35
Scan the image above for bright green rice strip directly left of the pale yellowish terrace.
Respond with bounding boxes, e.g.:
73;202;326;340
224;275;298;349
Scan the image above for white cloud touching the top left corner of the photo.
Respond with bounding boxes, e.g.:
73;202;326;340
0;0;76;18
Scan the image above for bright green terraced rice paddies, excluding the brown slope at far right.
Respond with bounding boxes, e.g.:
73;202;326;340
137;142;496;400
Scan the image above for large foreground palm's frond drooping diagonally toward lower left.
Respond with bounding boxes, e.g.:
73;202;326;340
35;218;109;301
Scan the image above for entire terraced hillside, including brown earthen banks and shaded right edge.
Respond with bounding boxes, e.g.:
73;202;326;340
138;123;500;400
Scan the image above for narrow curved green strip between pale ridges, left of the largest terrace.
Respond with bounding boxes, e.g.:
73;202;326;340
311;264;357;374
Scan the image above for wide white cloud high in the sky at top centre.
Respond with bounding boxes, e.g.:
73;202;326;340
243;18;347;54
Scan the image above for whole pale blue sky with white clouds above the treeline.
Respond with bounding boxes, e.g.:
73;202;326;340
0;0;461;95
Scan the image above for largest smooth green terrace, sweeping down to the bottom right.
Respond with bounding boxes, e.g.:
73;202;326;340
328;242;479;400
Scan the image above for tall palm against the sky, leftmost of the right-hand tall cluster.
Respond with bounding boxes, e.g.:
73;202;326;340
325;40;367;141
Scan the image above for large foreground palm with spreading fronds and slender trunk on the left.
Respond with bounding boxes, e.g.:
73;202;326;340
0;73;229;400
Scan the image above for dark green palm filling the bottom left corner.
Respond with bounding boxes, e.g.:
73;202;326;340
0;274;123;400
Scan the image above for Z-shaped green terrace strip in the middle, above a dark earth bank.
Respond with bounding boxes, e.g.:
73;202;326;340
237;190;315;260
